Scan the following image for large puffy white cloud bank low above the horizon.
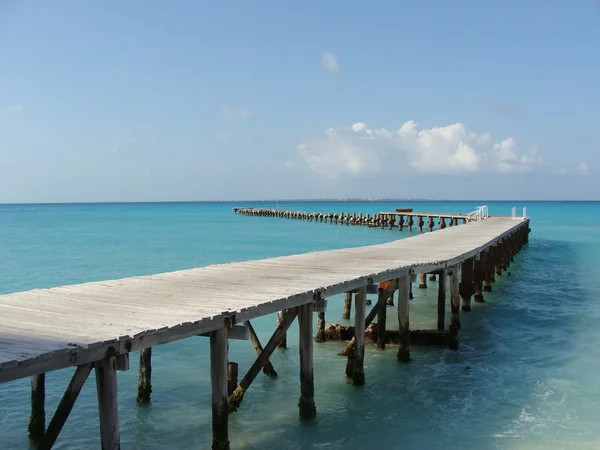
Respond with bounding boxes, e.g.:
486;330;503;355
298;121;542;178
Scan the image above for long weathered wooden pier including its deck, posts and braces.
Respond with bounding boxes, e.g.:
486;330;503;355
0;210;530;449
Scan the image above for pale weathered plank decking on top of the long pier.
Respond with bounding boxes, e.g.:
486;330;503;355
0;218;528;383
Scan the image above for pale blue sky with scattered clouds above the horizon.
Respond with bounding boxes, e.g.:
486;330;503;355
0;0;600;202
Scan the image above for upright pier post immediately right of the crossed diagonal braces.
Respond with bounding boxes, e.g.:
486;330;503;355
298;302;317;419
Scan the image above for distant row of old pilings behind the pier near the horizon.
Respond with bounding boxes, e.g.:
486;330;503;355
233;208;471;231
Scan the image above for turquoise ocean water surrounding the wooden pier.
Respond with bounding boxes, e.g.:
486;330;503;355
0;202;600;450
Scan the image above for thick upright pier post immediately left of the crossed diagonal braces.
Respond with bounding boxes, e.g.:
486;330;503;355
210;328;229;450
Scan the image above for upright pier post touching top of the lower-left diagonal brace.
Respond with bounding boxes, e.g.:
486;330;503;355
94;357;121;450
